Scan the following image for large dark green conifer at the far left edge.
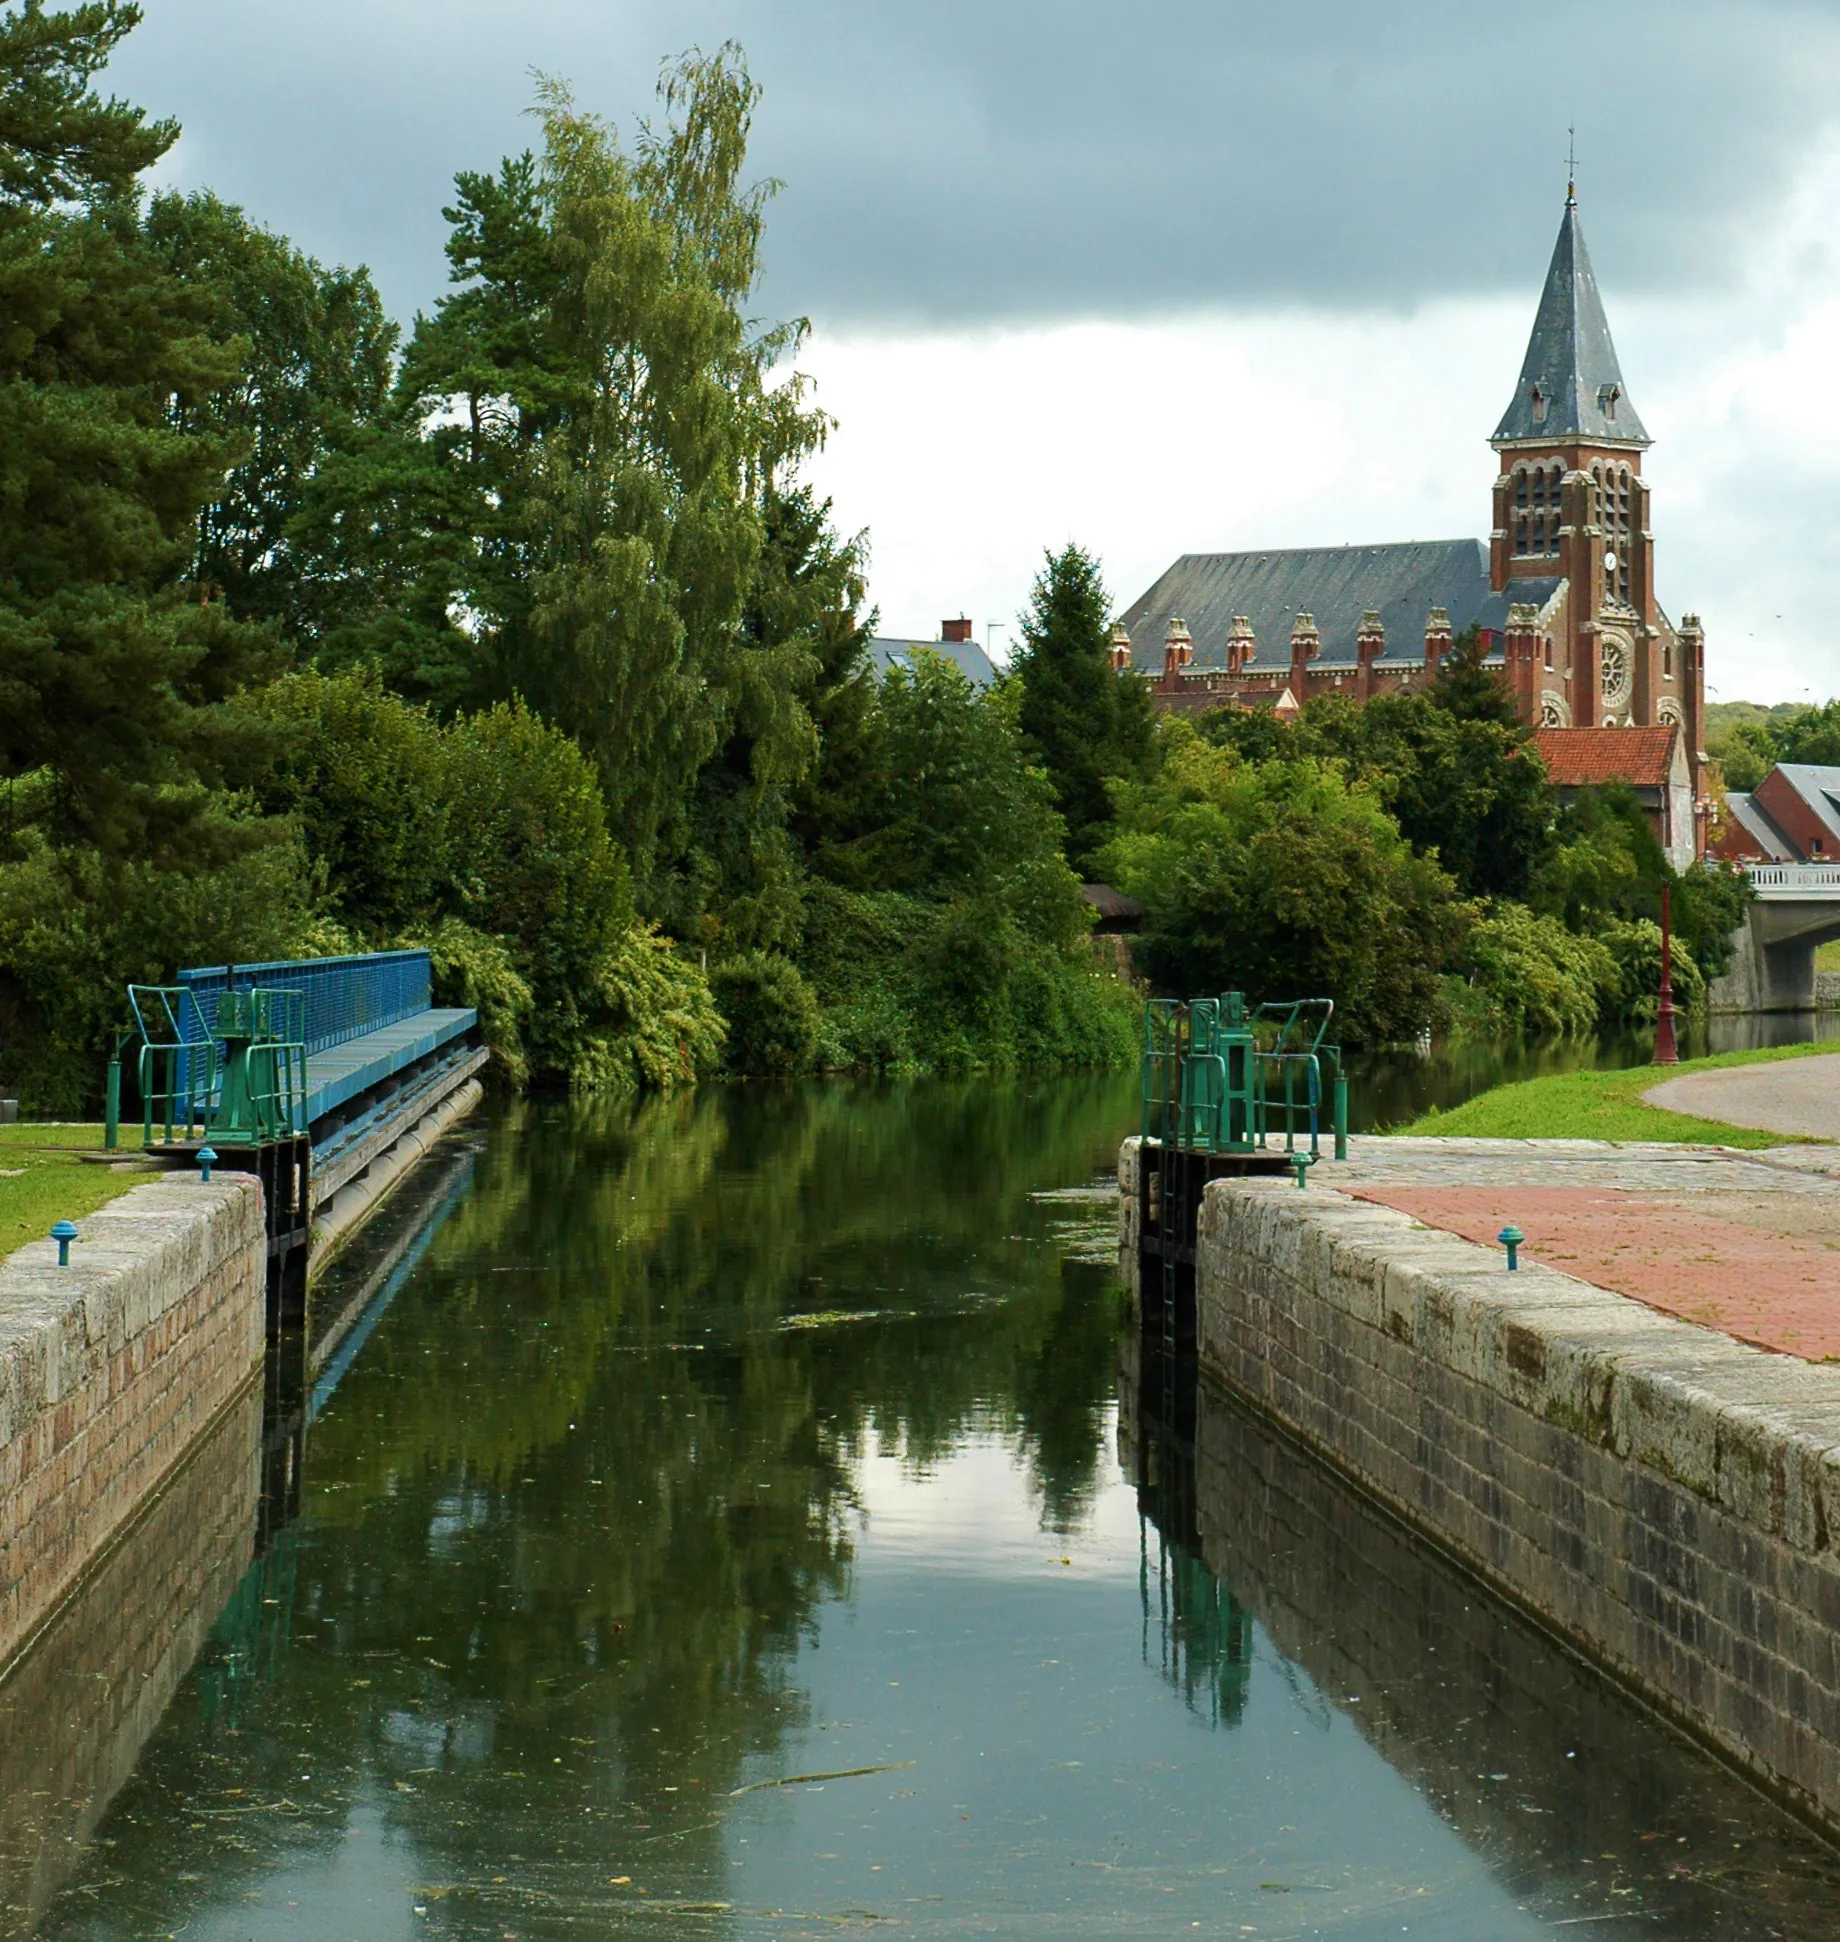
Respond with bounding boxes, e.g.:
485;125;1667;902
0;0;273;856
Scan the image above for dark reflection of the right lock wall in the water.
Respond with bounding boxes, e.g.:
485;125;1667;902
1121;1352;1840;1942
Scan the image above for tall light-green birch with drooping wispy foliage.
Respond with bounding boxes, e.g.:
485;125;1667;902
515;47;824;884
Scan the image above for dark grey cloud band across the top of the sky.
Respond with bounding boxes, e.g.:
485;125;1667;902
111;0;1840;324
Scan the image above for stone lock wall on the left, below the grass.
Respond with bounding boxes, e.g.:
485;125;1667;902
0;1175;266;1676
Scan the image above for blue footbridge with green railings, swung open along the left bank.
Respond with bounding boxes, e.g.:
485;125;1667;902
126;950;488;1266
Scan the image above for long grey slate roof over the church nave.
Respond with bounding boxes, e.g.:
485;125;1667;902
1123;540;1562;674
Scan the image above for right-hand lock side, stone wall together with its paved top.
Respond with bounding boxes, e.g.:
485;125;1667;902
1121;1140;1840;1827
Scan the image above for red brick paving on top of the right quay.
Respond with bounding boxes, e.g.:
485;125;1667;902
1350;1187;1840;1361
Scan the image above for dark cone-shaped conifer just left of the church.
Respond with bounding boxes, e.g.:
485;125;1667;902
1016;542;1152;876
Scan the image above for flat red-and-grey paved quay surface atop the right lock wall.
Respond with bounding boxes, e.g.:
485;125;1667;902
1312;1134;1840;1361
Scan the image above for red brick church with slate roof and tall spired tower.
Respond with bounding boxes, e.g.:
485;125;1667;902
1113;188;1706;860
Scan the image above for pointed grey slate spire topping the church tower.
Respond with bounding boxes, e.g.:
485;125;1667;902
1488;184;1650;447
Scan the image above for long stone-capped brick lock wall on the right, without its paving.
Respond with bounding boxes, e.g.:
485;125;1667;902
1199;1183;1840;1827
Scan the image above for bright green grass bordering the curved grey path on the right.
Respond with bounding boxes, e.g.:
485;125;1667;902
1397;1043;1840;1146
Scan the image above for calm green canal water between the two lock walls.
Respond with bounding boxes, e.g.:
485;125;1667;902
0;1078;1840;1942
